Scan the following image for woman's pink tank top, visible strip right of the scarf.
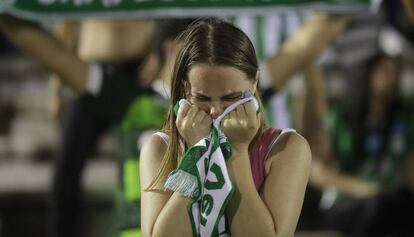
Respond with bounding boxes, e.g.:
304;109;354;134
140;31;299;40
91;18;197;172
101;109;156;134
250;128;281;191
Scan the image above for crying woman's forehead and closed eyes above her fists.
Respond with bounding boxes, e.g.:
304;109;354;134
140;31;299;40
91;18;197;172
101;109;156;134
186;64;256;119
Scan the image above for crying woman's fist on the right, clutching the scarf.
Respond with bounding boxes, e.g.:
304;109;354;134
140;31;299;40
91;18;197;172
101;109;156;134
221;101;260;152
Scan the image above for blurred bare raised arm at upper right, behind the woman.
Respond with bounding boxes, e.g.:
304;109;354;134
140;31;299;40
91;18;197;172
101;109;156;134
266;13;350;90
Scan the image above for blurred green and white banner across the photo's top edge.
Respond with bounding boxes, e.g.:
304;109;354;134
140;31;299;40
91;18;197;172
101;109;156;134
0;0;372;20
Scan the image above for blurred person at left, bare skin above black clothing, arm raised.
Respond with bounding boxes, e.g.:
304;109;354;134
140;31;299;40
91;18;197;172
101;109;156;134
1;15;153;236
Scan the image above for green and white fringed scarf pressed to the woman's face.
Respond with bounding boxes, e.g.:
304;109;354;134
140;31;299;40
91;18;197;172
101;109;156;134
164;95;259;237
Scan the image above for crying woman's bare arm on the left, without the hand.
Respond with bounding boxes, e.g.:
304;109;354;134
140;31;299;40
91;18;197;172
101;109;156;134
140;135;192;237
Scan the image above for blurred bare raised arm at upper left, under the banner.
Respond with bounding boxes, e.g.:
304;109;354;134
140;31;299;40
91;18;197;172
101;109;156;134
0;15;89;94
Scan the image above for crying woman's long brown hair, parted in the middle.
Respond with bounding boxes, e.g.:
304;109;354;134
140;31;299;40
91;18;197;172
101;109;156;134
146;18;264;191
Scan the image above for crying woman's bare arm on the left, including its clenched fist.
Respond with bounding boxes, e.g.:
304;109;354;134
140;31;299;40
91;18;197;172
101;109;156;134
140;101;212;237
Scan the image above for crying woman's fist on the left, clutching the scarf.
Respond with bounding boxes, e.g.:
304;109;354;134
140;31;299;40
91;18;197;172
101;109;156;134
175;103;212;147
